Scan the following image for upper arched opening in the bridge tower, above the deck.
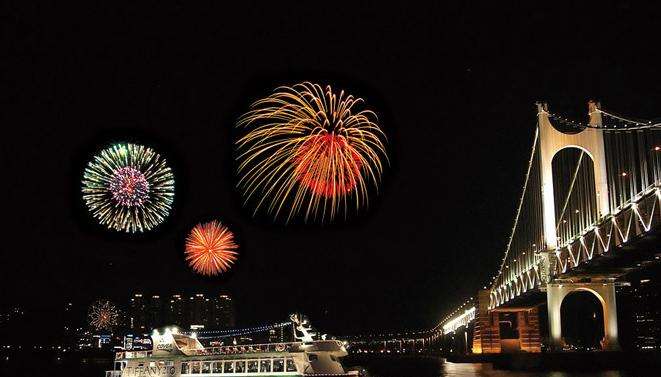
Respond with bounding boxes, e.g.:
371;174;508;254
551;145;599;245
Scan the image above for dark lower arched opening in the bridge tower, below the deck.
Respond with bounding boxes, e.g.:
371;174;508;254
560;289;605;351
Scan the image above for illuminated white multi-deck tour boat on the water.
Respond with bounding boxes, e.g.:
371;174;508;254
106;315;360;377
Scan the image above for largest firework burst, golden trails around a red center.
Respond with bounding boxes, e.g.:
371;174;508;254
236;82;387;222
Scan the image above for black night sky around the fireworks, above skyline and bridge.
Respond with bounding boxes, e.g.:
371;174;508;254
0;1;661;334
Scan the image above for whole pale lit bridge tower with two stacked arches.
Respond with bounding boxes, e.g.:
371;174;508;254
537;101;619;350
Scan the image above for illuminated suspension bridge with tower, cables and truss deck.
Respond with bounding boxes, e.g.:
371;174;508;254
342;102;661;353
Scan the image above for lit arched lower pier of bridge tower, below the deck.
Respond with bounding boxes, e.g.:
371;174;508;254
546;281;620;351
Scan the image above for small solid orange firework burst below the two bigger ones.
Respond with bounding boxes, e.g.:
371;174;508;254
186;220;239;276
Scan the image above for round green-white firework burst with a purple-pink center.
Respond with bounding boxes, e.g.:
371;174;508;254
82;144;174;233
